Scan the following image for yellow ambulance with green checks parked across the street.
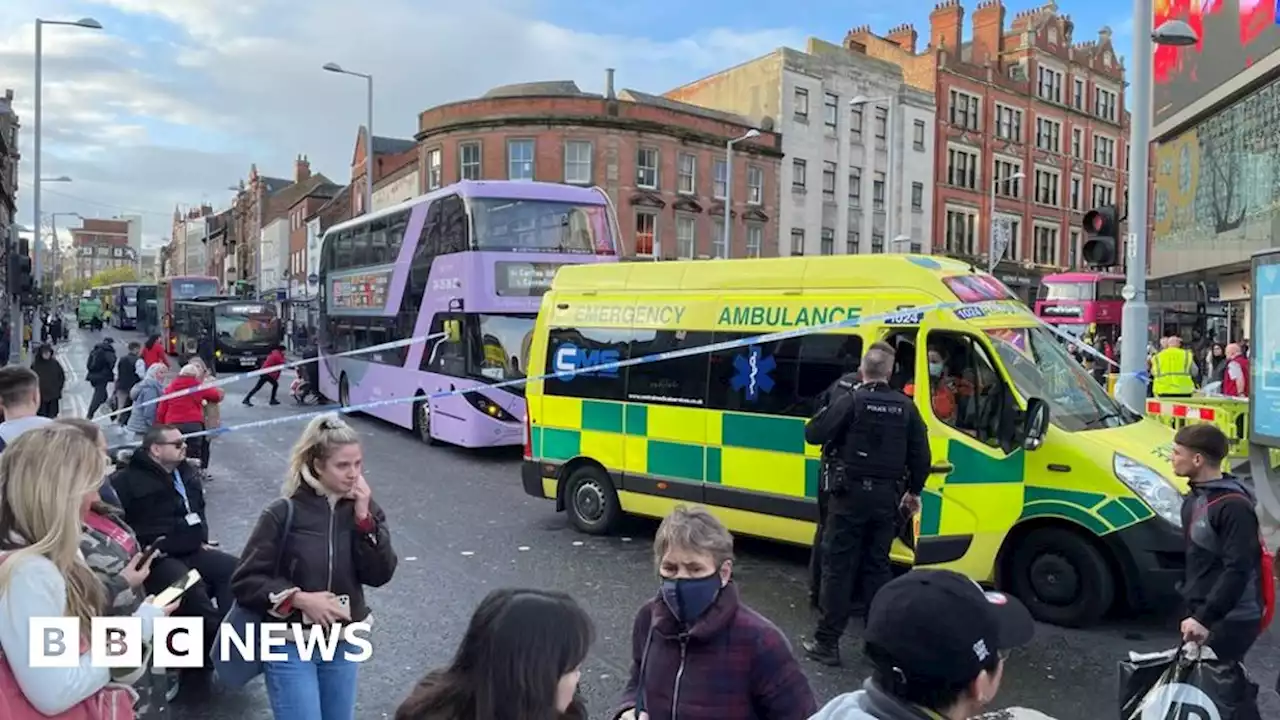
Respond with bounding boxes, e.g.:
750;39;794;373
522;255;1185;626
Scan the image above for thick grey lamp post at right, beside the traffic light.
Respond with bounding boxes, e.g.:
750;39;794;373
1115;16;1197;413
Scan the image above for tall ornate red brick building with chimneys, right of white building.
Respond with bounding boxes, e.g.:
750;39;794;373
845;0;1129;300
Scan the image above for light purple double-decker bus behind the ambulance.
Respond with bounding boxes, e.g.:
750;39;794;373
319;181;618;447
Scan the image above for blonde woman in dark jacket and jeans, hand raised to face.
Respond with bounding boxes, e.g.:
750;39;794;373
232;413;396;720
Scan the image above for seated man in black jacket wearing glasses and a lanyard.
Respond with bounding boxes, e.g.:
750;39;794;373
111;425;237;691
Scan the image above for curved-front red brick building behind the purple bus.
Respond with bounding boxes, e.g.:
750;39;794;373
416;70;782;259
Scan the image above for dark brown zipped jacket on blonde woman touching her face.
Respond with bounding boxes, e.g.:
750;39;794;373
232;470;397;623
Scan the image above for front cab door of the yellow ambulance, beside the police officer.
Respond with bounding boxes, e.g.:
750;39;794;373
914;311;1024;580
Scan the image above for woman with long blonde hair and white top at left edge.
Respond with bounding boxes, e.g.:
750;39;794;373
0;424;173;720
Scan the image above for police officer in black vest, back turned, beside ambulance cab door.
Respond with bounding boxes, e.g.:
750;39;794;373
803;342;932;666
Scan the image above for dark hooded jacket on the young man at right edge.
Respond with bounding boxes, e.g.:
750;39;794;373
1181;475;1263;628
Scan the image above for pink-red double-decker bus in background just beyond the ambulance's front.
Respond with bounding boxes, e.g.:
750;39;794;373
1036;272;1124;340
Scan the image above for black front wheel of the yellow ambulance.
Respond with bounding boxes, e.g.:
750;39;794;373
1009;528;1116;628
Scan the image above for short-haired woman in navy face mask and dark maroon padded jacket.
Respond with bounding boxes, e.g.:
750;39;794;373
612;506;817;720
